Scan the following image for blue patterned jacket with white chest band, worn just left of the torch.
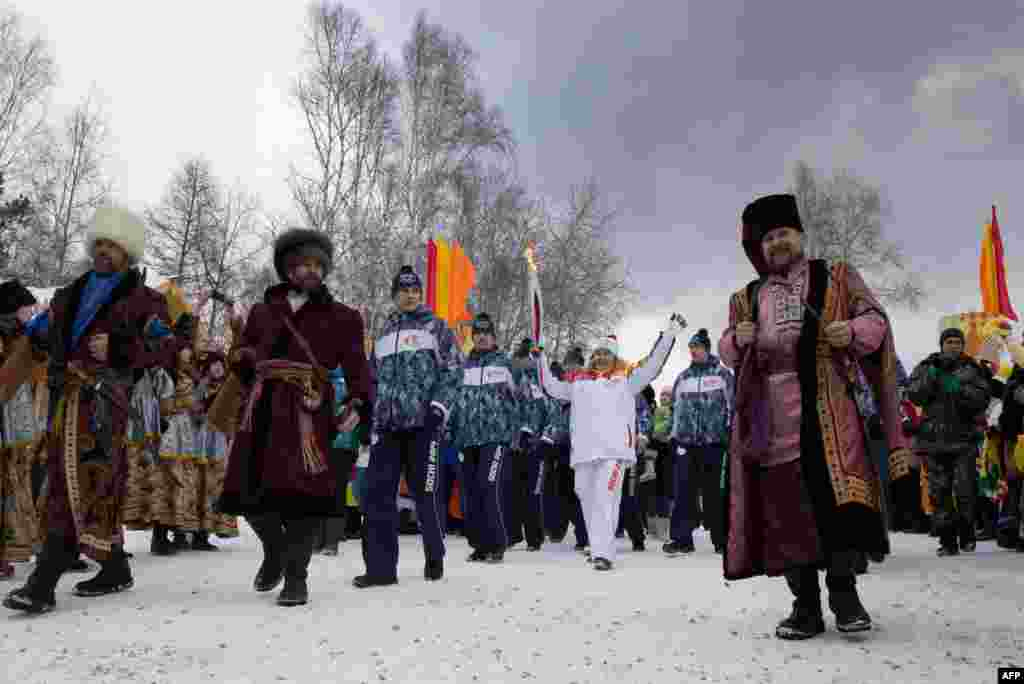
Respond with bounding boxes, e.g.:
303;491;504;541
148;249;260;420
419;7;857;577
449;350;524;450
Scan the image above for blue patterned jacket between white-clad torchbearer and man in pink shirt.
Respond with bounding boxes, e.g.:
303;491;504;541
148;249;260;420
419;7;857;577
672;354;735;446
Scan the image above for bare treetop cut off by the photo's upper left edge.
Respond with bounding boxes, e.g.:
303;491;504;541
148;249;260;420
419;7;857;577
0;10;56;177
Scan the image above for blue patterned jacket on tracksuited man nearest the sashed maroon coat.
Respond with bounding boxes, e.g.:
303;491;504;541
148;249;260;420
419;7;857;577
370;306;462;432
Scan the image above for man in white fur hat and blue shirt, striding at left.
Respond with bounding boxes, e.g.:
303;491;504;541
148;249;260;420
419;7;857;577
4;207;193;613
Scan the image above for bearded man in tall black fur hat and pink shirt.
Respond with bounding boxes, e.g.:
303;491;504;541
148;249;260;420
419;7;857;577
719;195;910;639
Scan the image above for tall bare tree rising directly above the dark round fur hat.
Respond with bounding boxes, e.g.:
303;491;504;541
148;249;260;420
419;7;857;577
290;2;398;242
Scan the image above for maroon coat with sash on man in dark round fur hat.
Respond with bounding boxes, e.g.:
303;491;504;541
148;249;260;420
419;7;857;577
217;284;374;517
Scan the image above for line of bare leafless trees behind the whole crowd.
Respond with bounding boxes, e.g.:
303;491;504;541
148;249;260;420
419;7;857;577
0;1;920;353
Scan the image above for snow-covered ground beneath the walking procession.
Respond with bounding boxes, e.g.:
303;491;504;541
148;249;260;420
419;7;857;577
0;528;1024;684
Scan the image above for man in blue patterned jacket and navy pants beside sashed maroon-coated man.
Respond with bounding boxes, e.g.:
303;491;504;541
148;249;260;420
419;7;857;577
352;266;463;589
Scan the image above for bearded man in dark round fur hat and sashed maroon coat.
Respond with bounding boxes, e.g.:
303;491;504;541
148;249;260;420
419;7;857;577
218;229;374;606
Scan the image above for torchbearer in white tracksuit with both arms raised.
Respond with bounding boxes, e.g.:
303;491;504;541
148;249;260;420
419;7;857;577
538;315;686;570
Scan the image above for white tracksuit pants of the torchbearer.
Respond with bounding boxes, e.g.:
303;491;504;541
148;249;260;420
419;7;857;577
572;459;629;561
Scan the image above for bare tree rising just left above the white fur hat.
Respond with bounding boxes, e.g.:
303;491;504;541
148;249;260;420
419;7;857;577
32;99;111;285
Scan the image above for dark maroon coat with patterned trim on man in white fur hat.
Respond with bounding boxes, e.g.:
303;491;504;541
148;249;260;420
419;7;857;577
46;269;187;560
